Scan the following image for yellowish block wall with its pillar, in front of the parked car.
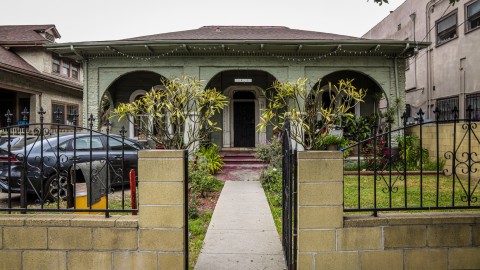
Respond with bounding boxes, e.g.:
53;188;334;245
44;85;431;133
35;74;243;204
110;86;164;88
0;151;185;270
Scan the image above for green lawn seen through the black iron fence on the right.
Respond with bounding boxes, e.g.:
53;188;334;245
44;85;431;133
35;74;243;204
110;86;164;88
344;175;480;211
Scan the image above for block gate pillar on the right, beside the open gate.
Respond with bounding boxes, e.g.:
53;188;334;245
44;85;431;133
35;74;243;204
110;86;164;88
298;151;343;269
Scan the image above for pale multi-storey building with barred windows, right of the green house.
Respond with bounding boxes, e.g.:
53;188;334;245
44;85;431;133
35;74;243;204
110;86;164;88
363;0;480;120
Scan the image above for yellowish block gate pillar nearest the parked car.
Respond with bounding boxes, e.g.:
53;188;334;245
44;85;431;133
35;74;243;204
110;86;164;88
138;150;187;269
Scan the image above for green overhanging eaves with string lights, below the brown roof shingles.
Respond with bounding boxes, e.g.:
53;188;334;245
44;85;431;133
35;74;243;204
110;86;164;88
46;40;430;60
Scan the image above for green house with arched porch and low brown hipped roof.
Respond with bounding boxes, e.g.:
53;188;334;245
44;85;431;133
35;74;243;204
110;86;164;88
47;26;427;148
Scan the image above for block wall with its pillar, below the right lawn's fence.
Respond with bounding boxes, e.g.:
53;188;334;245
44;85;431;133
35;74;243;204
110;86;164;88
298;152;480;270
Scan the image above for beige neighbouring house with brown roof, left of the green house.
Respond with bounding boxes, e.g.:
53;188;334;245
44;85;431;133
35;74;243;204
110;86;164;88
0;25;83;127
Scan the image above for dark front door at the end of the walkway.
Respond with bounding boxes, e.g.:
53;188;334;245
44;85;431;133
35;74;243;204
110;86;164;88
233;101;255;147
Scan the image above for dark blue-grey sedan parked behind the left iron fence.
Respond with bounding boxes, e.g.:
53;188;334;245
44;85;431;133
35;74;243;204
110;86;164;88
0;133;144;201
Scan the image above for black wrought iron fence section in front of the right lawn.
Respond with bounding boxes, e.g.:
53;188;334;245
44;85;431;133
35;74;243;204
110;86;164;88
343;107;480;215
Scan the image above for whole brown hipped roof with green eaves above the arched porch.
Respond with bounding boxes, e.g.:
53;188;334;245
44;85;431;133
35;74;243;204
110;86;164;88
46;26;429;60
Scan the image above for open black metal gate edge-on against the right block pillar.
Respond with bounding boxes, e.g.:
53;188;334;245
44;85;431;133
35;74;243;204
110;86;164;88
282;119;297;270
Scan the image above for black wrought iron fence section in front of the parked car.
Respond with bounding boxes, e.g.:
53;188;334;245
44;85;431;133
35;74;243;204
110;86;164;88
0;108;144;217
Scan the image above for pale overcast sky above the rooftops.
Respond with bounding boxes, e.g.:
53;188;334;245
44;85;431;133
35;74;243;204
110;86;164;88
0;0;404;42
